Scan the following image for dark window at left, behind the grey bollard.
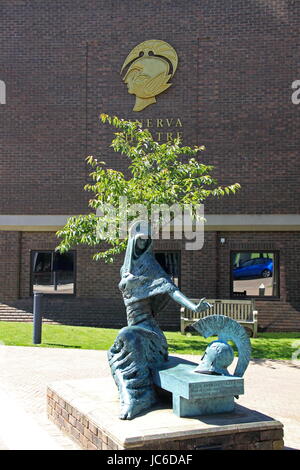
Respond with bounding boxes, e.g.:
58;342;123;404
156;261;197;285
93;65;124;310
31;251;75;294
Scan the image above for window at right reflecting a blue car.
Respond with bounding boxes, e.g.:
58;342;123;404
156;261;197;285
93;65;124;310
231;251;279;298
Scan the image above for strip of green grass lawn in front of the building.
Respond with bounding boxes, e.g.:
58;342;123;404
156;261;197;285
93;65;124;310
0;322;300;359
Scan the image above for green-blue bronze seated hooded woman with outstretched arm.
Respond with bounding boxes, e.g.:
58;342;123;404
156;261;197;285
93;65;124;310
108;222;210;419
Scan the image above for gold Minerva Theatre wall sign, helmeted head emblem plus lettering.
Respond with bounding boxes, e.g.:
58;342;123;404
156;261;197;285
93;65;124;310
121;39;183;142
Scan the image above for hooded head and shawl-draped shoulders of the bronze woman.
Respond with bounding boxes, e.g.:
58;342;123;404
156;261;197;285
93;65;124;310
119;221;178;313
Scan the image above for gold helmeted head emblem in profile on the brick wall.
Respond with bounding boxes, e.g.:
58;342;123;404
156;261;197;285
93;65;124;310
121;39;178;111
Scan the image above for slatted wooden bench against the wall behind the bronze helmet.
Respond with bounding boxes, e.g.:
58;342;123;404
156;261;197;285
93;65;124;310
180;299;258;338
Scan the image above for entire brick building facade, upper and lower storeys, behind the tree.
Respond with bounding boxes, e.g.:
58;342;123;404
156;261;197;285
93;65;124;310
0;0;300;331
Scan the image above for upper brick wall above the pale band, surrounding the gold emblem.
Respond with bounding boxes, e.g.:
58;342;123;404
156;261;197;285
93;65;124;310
0;0;300;214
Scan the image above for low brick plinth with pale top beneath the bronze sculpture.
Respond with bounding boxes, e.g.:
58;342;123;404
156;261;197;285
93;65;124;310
47;377;283;450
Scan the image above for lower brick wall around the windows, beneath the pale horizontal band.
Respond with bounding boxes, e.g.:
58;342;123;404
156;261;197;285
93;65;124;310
0;232;300;331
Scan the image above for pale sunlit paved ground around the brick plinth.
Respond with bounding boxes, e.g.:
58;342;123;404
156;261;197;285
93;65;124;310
0;346;300;450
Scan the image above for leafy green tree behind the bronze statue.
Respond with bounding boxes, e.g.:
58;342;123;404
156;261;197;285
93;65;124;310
57;114;240;262
